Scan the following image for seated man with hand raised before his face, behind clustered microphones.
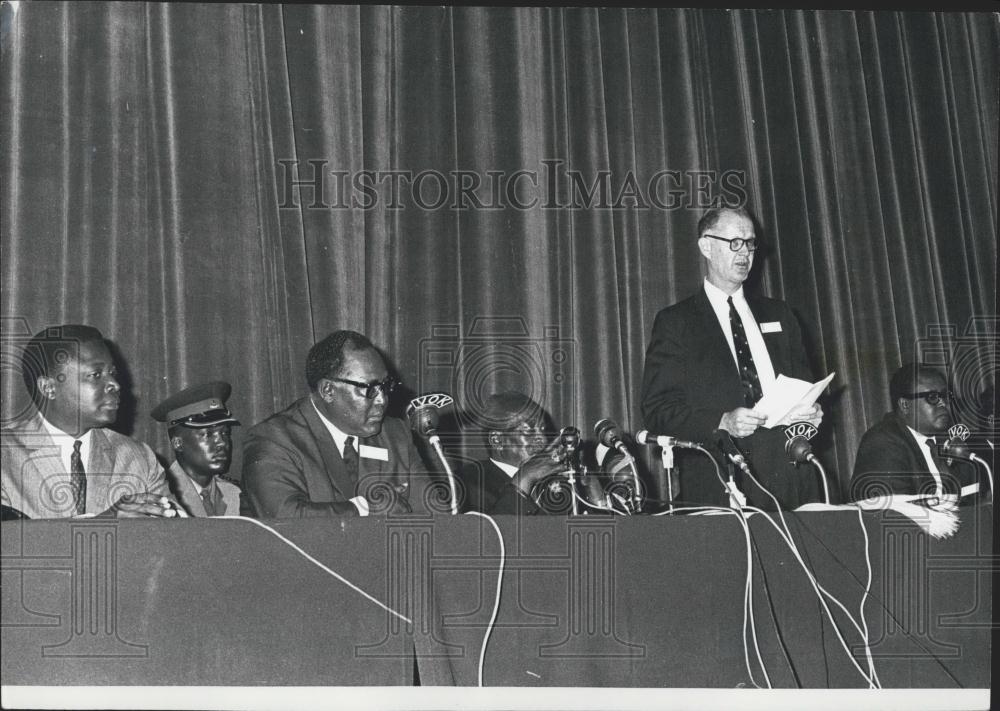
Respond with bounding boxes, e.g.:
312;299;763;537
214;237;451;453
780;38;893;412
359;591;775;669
456;391;552;513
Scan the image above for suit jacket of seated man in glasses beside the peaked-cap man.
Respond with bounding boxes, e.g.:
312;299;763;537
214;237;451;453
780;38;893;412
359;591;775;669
243;396;434;518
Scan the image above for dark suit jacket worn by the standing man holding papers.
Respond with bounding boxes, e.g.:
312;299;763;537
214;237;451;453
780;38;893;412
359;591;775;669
642;289;821;509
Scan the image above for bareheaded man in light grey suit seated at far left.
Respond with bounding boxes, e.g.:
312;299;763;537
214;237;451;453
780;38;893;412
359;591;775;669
0;325;179;518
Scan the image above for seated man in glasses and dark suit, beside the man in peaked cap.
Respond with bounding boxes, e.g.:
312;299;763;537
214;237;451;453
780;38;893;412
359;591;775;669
243;331;428;518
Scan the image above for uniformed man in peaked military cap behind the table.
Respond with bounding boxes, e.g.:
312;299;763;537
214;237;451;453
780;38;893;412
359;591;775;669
150;381;246;517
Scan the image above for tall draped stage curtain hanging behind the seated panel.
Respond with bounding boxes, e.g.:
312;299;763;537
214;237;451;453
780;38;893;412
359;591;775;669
0;3;1000;498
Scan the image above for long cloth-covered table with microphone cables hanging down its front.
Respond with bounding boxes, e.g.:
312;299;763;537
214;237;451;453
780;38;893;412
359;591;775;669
0;507;997;688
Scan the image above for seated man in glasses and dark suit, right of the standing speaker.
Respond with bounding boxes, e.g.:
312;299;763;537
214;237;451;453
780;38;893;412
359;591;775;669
850;363;980;504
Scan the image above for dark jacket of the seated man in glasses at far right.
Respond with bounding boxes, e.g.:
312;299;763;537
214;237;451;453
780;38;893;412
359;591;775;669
850;412;988;504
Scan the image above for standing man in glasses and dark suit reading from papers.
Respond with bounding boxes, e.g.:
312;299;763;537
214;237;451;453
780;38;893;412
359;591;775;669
642;208;823;509
